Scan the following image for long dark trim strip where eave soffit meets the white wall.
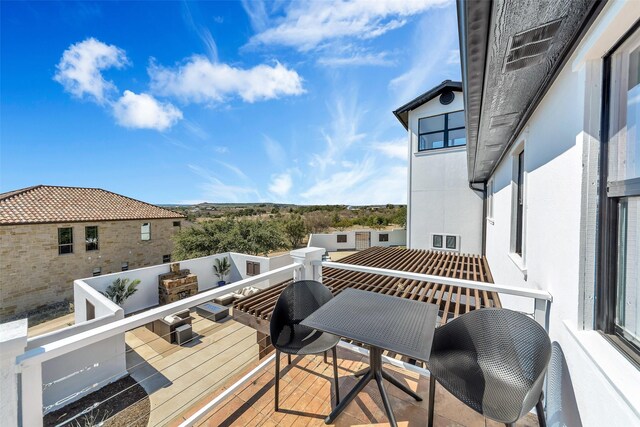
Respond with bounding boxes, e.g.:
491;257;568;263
488;0;609;180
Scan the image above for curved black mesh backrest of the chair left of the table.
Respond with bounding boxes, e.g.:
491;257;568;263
270;280;333;343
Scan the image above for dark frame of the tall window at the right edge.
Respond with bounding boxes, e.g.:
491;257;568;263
594;22;640;367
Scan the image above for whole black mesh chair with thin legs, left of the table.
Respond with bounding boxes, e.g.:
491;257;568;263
270;280;340;411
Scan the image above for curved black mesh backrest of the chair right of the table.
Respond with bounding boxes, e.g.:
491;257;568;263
434;308;551;420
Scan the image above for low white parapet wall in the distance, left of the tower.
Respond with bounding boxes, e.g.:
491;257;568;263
307;229;407;252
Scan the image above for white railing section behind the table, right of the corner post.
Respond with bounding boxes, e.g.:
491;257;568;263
312;261;553;331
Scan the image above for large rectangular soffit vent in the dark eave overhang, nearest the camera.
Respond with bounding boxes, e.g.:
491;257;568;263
504;18;564;72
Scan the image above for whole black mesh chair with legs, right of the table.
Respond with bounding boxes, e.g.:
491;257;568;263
429;308;551;426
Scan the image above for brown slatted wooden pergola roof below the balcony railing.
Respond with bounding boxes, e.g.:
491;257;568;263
233;247;501;362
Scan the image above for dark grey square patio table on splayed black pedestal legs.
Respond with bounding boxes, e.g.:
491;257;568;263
301;289;438;426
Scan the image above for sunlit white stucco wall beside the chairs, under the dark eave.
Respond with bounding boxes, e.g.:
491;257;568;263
486;1;640;426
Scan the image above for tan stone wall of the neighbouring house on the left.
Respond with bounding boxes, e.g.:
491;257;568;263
0;218;184;321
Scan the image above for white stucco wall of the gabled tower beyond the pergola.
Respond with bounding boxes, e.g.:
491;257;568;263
407;92;483;254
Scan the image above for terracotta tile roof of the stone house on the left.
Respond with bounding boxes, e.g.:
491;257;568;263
0;185;184;224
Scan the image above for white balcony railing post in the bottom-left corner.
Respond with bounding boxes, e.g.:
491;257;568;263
0;319;28;426
